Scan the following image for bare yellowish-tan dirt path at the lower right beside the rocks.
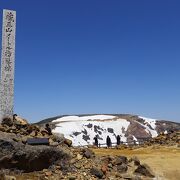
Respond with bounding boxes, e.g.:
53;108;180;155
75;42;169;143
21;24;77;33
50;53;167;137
93;146;180;180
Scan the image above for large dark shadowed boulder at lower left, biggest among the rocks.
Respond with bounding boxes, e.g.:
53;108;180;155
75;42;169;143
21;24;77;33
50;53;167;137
0;144;69;172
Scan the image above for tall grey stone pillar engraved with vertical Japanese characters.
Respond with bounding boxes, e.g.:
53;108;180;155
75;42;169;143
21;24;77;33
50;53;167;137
0;10;16;123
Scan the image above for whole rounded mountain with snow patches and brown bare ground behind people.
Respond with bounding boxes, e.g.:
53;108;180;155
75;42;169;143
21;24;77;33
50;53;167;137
37;114;180;146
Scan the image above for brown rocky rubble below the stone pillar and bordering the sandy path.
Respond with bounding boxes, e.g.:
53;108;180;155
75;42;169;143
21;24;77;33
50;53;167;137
0;118;179;180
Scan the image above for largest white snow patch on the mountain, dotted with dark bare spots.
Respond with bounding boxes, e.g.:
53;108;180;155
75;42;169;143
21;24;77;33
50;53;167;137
53;115;130;146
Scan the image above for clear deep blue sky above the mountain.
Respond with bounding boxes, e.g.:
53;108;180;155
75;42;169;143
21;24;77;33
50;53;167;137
0;0;180;122
